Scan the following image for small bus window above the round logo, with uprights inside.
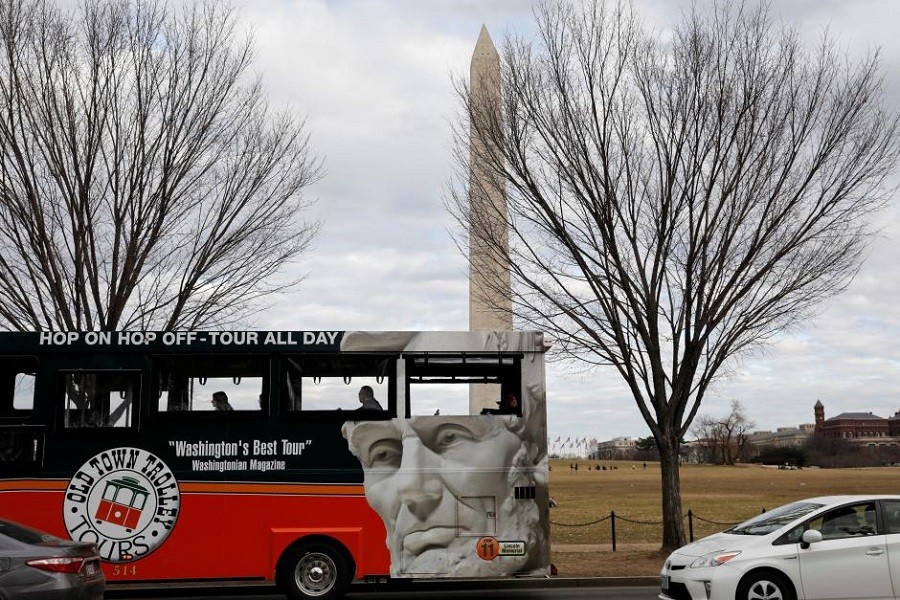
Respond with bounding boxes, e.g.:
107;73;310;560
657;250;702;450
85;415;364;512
63;371;141;428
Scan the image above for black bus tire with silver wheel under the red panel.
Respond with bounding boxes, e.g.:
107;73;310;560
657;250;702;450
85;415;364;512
277;540;352;600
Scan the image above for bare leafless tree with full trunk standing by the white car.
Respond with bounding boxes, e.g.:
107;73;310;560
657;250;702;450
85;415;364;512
447;2;898;548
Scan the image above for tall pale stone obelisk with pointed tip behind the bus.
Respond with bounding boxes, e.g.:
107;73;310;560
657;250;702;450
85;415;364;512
469;25;513;414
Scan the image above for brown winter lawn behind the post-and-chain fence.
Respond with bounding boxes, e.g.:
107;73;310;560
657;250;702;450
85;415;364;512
550;460;900;577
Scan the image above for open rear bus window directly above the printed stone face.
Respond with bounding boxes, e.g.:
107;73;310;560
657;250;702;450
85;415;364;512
406;355;522;416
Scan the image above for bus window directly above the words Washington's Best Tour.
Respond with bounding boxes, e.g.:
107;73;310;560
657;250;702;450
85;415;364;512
155;355;269;413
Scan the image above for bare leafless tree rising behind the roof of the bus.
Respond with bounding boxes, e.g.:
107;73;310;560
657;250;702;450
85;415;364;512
0;0;319;330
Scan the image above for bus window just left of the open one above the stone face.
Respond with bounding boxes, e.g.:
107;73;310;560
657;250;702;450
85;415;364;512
282;355;396;416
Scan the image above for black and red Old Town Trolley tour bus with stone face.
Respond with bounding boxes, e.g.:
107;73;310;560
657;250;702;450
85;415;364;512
0;331;550;598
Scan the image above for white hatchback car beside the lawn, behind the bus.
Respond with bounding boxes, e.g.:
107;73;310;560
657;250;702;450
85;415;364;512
659;495;900;600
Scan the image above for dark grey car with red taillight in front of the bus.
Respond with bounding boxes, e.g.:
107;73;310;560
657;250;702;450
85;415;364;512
0;519;106;600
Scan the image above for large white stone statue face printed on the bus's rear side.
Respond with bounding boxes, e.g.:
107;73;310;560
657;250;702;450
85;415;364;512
342;404;546;576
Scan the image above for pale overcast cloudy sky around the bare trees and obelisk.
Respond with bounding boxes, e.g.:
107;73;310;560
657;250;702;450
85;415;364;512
230;0;900;450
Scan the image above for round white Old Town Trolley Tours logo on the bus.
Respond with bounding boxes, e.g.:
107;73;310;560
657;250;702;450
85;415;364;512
63;448;181;563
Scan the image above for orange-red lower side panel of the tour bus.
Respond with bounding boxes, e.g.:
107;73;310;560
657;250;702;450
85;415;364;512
0;480;390;582
